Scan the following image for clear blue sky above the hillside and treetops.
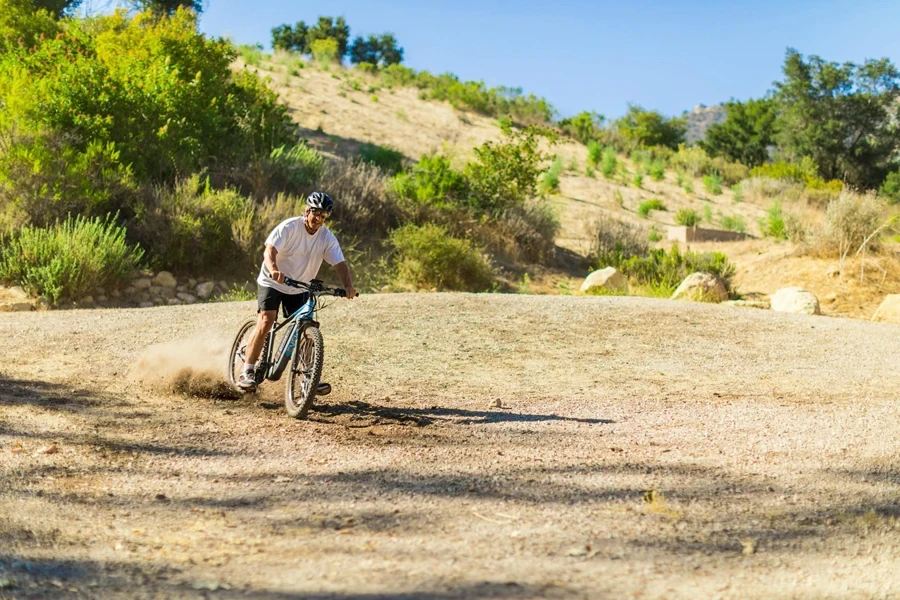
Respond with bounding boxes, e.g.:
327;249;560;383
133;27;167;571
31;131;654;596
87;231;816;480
186;0;900;118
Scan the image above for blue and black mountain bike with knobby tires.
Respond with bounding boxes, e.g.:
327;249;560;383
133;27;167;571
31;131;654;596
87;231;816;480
227;277;346;419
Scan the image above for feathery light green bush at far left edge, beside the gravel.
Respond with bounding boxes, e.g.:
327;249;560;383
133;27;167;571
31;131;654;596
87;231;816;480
0;216;143;305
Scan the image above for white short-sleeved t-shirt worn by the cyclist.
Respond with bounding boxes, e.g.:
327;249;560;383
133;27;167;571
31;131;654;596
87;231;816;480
256;217;344;294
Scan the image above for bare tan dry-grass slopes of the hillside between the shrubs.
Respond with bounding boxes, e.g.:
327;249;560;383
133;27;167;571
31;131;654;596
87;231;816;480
241;55;900;318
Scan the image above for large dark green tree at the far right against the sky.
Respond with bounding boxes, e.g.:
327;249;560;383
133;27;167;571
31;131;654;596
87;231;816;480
775;48;900;187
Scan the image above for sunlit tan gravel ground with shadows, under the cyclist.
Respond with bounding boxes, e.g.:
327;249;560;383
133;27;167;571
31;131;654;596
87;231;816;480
0;294;900;600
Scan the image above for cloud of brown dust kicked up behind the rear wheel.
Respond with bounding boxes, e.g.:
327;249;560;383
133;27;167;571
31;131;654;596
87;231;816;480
128;339;240;399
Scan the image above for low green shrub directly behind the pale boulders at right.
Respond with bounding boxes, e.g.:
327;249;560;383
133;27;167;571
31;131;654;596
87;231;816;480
613;245;735;296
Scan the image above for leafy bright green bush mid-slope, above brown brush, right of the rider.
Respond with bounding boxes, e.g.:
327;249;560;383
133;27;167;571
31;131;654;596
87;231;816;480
465;127;552;217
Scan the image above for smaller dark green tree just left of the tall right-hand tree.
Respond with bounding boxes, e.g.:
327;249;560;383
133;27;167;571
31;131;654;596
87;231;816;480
700;98;777;167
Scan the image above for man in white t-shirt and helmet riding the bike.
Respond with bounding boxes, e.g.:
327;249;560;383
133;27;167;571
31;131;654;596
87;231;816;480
237;192;356;391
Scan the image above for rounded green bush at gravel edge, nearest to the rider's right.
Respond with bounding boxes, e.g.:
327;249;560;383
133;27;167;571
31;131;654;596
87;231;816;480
390;223;493;292
